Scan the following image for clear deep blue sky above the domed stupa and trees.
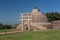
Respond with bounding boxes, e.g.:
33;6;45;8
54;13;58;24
0;0;60;24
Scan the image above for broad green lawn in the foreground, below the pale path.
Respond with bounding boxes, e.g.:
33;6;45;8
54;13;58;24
0;30;60;40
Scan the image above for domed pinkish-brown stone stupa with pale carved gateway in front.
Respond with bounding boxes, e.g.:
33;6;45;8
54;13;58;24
17;7;51;31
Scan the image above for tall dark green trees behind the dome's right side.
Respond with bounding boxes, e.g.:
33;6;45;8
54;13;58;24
45;12;60;21
